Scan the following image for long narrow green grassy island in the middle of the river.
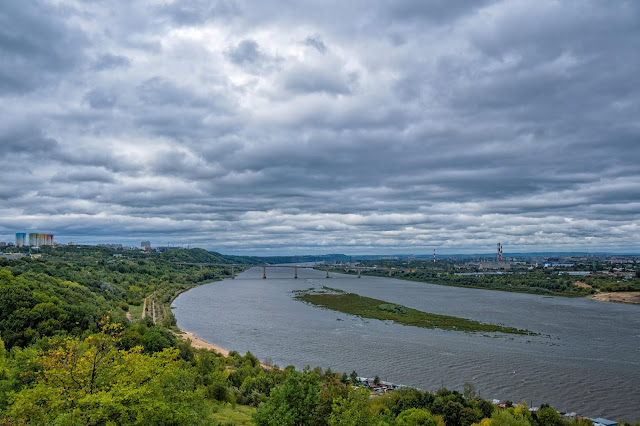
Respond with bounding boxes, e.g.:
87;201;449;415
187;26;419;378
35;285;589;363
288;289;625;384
294;290;536;334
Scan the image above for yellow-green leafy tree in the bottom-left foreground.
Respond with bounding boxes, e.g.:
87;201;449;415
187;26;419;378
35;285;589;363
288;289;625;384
7;324;204;424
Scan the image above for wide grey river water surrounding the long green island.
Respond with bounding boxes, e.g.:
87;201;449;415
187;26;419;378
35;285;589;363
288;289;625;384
173;268;640;421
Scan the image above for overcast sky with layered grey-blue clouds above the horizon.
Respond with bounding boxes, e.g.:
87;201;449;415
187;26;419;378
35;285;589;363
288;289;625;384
0;0;640;255
